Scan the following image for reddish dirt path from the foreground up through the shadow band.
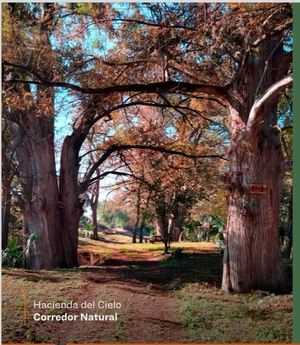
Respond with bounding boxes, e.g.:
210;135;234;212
52;249;187;344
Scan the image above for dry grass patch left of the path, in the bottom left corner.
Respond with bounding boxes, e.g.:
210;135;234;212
2;269;85;343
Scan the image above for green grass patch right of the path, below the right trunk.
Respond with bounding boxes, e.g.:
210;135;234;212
178;284;292;343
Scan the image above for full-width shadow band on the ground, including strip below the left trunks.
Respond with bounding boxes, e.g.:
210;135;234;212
3;252;292;293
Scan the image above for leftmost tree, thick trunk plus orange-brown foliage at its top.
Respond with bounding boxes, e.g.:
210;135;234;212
4;4;63;268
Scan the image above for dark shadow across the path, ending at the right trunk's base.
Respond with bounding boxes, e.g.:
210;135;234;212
81;253;222;290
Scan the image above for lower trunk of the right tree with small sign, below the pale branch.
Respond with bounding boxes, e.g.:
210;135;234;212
223;117;285;292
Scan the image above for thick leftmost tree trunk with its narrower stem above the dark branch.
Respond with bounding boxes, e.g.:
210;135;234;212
4;4;64;269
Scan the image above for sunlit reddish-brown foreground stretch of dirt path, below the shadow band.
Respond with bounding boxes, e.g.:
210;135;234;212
60;281;186;344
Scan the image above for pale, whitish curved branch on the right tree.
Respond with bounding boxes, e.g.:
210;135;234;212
247;76;293;133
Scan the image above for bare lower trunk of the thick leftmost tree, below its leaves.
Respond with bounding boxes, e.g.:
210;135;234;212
13;118;64;269
